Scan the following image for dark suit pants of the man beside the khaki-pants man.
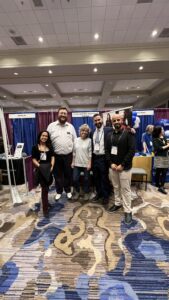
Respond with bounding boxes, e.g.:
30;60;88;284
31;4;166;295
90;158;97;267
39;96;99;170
93;155;111;199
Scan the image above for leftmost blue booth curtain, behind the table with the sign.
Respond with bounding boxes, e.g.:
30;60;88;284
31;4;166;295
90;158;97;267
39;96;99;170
12;118;37;155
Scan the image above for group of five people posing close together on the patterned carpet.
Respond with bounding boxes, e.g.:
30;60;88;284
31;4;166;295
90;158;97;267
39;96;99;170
32;107;169;224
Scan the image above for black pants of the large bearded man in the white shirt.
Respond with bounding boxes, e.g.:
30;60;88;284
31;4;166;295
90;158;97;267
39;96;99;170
53;153;72;194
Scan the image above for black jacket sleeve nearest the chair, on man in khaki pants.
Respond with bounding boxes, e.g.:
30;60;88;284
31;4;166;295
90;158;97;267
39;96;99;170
121;132;136;167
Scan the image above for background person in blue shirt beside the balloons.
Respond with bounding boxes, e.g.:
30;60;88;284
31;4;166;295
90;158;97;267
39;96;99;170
141;125;154;154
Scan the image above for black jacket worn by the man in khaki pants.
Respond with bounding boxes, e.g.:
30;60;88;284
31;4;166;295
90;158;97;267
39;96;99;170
105;129;136;170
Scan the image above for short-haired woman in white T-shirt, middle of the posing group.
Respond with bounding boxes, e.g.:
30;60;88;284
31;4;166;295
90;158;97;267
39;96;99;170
72;124;92;201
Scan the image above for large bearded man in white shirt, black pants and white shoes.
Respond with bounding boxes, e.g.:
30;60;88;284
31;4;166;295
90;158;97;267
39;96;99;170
47;107;77;200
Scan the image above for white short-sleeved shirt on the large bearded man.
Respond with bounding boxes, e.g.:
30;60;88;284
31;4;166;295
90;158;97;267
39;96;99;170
47;120;77;154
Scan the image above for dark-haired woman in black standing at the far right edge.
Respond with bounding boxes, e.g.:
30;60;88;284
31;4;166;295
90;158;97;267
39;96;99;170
152;126;169;195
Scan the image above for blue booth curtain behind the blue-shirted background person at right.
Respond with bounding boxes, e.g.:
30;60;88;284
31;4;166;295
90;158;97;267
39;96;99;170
136;115;154;152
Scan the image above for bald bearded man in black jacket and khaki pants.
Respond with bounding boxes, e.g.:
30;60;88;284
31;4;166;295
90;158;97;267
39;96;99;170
105;114;135;224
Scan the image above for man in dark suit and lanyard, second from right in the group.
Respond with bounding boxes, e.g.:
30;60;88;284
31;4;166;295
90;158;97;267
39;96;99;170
91;113;112;206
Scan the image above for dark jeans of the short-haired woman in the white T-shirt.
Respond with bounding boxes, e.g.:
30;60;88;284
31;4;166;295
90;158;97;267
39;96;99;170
73;167;90;193
